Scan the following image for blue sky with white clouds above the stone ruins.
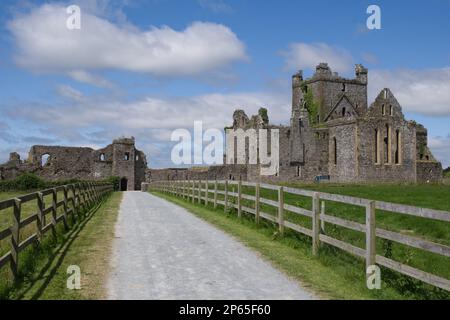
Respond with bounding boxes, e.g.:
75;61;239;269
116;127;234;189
0;0;450;167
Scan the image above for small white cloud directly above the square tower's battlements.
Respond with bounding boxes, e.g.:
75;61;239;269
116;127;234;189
281;43;353;72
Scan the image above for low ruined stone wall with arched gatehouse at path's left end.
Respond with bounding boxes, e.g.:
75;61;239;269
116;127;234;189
0;138;147;190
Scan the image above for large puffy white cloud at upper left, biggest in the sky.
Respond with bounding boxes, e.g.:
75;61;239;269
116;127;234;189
8;4;247;76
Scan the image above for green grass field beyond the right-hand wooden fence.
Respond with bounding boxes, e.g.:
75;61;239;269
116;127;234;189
155;184;450;299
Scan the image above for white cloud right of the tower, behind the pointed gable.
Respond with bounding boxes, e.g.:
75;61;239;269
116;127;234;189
369;67;450;116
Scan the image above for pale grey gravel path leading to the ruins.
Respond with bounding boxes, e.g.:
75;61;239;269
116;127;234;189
107;192;314;300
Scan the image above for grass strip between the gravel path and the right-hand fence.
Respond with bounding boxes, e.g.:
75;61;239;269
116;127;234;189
154;192;415;299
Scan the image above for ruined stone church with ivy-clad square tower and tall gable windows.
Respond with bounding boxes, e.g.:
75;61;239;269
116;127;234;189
233;63;442;183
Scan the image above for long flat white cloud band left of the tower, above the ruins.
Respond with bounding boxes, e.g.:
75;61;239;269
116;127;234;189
10;91;290;131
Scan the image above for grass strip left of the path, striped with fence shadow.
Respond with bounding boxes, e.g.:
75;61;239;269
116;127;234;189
0;192;122;300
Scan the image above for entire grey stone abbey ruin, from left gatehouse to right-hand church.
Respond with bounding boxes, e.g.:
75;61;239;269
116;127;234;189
0;63;443;190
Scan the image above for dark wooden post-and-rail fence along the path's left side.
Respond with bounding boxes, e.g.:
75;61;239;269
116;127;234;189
0;182;113;277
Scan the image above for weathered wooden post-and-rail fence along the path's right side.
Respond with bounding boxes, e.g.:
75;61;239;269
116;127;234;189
143;180;450;291
